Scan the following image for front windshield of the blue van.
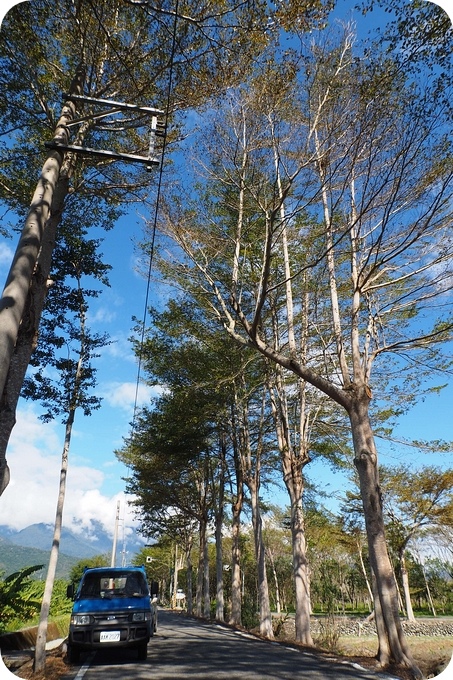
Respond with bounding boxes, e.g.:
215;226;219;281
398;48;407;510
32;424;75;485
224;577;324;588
79;571;148;599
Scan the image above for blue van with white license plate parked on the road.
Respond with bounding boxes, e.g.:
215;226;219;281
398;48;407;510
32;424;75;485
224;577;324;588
67;567;158;663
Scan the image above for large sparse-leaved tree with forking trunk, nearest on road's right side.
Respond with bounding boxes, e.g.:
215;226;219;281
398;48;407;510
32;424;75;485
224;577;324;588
154;19;453;677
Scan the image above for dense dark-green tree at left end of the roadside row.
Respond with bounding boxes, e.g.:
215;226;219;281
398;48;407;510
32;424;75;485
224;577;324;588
118;318;225;617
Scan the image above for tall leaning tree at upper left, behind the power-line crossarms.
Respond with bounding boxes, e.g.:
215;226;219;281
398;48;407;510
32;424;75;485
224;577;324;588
0;0;268;493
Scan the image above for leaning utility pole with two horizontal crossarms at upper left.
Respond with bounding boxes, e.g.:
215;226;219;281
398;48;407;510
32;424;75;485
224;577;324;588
0;77;165;495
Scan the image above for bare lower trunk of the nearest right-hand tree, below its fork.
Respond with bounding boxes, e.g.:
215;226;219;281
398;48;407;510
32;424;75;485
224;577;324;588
349;394;422;678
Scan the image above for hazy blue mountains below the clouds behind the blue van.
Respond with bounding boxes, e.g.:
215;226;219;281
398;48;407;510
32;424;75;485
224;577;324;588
0;522;143;578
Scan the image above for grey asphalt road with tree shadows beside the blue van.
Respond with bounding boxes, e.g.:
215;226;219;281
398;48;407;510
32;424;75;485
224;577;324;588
60;610;396;680
